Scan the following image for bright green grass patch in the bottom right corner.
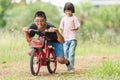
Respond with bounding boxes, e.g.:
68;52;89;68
86;60;120;80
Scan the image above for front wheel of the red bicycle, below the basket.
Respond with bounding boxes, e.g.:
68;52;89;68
30;49;41;76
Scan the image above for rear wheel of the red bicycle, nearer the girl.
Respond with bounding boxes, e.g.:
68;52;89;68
47;49;57;74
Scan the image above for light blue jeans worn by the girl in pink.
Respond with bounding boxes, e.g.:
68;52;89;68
64;40;77;66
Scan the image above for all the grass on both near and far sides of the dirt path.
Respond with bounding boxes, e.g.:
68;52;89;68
0;31;120;80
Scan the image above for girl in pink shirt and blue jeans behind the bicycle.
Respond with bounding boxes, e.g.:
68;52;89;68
59;2;80;73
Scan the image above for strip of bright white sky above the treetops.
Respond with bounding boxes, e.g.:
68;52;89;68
13;0;120;7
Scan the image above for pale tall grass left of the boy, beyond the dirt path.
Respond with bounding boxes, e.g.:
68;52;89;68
0;32;29;63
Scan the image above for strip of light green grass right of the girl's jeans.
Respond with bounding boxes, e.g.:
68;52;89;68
76;41;120;56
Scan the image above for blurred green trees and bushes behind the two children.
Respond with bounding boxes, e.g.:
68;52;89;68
0;0;120;45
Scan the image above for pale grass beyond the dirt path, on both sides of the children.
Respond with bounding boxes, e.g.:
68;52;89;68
0;31;120;62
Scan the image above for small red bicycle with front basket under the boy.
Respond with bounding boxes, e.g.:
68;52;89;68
23;29;57;76
